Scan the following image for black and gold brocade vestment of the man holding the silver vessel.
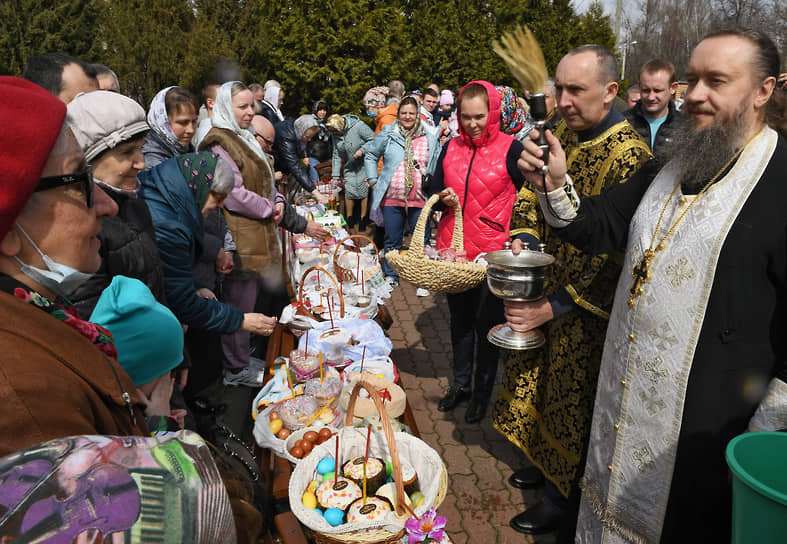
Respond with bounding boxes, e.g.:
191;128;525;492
492;121;651;496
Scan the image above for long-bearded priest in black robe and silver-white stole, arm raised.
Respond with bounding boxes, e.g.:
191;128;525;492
506;30;787;543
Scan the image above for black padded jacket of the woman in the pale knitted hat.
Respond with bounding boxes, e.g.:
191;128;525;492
67;189;166;319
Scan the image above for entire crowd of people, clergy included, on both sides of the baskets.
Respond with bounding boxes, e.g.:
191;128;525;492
0;25;787;543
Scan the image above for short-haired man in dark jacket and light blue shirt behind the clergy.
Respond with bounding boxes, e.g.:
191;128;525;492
624;59;683;163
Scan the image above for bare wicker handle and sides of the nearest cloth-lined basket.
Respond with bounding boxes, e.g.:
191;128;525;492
290;378;448;544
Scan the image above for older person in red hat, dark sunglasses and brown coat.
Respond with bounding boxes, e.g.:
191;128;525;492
0;77;147;455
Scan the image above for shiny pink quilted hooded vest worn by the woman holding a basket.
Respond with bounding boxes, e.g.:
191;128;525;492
437;81;516;259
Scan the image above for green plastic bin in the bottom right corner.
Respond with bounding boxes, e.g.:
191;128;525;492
727;431;787;544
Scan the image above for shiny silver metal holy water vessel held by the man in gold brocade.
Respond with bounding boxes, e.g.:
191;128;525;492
485;243;555;350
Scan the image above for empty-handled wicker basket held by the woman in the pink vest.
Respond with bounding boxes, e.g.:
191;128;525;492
385;195;486;293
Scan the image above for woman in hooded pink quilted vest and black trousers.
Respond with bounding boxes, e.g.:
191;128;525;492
429;81;525;423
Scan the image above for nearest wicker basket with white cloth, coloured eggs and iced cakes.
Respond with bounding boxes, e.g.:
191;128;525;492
289;376;448;544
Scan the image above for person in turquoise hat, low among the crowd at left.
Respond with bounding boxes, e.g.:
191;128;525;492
90;276;186;434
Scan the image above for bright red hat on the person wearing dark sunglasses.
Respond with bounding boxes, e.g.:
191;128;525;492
0;76;66;240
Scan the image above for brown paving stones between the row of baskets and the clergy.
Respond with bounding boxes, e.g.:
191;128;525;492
388;281;555;544
